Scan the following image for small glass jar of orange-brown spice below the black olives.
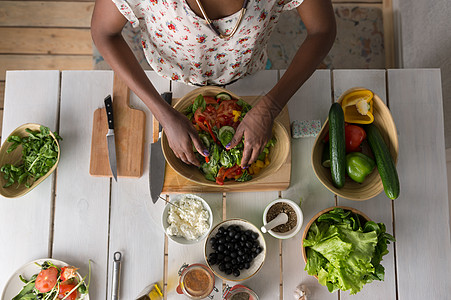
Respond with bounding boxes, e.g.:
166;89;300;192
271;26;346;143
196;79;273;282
176;264;215;299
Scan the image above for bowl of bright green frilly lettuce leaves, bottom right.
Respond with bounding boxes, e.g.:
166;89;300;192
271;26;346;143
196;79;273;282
302;206;395;295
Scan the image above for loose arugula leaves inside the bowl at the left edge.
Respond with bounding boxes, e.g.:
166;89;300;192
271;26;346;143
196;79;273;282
0;126;62;188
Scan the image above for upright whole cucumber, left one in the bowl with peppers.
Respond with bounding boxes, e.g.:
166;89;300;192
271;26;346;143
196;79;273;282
329;103;346;188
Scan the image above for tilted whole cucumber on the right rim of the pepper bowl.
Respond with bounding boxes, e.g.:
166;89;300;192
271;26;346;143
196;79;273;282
365;124;400;200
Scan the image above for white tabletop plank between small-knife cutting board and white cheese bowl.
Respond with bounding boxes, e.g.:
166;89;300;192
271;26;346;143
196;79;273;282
108;71;170;299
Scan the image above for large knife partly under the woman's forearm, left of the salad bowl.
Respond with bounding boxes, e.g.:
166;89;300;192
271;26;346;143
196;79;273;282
149;92;172;203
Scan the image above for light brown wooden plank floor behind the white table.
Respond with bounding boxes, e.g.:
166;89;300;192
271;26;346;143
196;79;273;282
0;0;394;137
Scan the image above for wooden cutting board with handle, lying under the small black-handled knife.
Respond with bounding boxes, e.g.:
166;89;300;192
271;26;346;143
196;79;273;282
89;74;146;178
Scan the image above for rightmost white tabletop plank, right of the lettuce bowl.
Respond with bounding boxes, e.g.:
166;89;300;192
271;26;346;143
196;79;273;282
388;69;451;299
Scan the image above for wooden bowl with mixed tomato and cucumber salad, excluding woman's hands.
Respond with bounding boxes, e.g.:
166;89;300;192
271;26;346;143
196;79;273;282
161;86;290;188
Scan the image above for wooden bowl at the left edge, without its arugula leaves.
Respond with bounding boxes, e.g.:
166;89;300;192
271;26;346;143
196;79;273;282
0;123;61;198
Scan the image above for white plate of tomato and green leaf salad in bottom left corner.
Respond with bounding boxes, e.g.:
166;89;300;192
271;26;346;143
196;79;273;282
1;258;91;300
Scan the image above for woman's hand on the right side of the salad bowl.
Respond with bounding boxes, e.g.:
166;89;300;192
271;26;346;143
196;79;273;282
227;96;281;168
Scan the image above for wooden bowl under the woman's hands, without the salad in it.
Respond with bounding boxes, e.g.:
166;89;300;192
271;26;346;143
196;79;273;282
161;86;291;188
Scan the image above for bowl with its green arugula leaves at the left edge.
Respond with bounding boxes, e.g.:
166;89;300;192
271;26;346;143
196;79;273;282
0;123;61;198
